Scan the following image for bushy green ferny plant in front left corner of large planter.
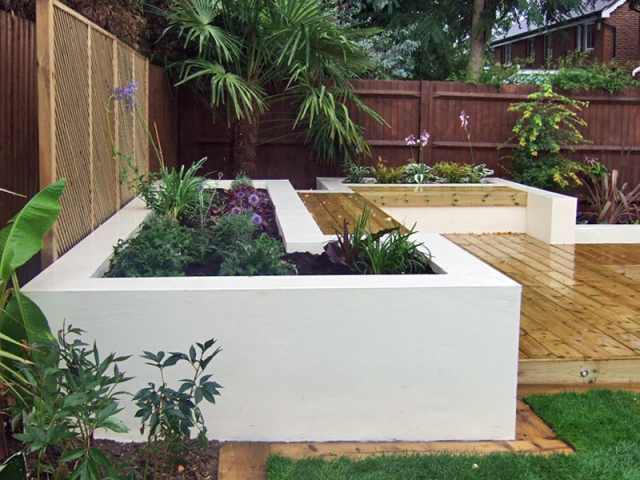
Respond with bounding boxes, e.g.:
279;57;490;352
105;216;195;277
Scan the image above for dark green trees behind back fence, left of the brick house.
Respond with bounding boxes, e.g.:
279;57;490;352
327;0;595;81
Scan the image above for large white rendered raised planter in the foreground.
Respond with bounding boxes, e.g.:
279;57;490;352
24;181;521;441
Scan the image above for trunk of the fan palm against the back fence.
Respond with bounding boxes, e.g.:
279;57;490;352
229;113;260;178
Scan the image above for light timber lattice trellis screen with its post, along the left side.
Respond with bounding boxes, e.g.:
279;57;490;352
36;0;149;263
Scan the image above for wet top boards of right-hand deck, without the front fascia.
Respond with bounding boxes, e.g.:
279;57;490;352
447;235;640;365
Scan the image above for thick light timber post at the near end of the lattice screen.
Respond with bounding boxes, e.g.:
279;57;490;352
36;0;58;269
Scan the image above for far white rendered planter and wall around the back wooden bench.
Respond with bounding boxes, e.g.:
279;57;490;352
316;177;577;244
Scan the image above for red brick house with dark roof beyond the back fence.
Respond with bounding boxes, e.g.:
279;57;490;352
491;0;640;68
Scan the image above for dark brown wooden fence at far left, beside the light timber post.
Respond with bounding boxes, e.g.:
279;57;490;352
0;11;39;283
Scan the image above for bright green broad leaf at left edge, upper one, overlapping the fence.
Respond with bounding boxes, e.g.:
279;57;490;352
0;178;67;284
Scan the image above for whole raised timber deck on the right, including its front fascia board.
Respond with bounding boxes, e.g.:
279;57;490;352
447;235;640;384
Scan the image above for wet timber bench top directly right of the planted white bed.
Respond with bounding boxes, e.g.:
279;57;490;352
298;192;406;235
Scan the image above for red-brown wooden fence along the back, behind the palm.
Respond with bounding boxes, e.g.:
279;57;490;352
179;80;640;188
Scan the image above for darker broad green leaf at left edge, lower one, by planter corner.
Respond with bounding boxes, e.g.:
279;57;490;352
0;291;55;361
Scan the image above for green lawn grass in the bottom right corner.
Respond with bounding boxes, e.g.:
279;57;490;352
267;389;640;480
